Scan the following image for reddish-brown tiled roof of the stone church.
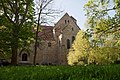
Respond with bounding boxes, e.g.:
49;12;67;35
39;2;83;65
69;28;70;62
34;13;80;41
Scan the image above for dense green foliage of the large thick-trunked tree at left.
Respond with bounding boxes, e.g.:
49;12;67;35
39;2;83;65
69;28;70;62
0;0;34;57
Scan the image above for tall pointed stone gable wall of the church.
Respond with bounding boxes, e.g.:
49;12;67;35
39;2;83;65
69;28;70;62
55;13;80;64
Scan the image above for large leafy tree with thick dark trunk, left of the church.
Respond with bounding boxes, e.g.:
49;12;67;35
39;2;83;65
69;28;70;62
0;0;33;64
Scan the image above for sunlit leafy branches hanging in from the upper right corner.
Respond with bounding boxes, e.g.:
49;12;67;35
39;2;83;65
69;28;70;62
84;0;120;42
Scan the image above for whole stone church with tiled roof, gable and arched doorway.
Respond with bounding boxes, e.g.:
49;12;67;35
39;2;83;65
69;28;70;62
18;13;80;65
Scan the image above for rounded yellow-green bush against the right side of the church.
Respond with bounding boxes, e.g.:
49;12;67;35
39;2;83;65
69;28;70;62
68;31;90;65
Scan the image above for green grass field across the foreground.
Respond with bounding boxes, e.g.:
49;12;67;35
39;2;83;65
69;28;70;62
0;65;120;80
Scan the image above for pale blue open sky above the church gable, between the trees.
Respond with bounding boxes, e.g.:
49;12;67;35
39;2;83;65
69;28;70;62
54;0;87;29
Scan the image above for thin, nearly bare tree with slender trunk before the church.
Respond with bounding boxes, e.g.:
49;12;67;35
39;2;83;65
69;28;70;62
33;0;61;65
